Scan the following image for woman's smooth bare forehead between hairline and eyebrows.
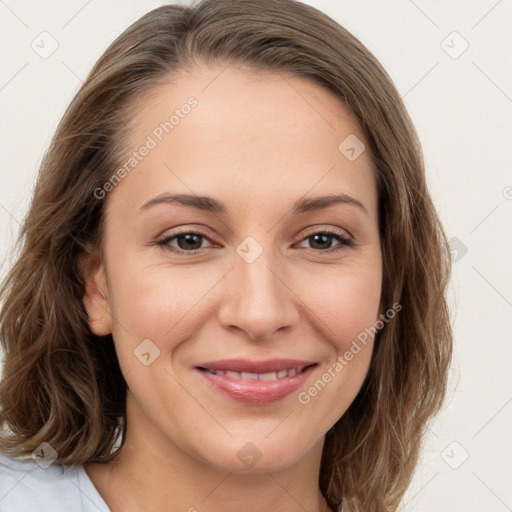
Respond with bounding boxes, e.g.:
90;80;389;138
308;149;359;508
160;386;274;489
107;65;376;216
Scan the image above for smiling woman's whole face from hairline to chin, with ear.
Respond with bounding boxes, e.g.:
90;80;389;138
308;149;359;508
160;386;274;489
84;66;382;471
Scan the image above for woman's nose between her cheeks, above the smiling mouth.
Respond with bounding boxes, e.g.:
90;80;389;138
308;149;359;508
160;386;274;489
219;246;300;341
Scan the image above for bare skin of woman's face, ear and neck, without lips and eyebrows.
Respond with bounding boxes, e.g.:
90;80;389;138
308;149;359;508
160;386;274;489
83;65;383;512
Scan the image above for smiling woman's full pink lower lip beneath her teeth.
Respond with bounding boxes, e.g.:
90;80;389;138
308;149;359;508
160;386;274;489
195;365;316;405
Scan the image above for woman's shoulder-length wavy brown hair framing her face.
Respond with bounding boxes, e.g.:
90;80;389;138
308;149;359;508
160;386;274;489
0;0;452;512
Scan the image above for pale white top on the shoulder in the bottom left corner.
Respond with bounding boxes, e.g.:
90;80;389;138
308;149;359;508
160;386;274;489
0;455;110;512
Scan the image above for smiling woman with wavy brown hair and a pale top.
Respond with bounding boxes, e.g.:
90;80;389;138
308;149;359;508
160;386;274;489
0;0;452;512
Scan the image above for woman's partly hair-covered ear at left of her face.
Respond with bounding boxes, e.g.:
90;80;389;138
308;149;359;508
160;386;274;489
79;248;112;336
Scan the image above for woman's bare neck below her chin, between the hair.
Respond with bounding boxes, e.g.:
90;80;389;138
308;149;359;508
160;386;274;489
84;392;329;512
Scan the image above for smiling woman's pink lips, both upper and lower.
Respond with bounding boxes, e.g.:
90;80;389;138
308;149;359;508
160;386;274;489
194;359;317;405
